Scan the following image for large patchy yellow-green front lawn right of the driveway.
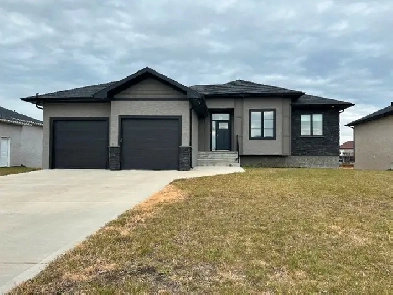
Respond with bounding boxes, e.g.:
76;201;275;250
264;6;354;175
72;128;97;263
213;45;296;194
13;169;393;294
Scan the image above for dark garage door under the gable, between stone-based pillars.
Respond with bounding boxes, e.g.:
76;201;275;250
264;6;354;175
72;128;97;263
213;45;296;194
121;117;181;170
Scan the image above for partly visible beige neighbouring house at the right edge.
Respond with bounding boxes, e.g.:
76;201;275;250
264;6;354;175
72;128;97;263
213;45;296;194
347;102;393;170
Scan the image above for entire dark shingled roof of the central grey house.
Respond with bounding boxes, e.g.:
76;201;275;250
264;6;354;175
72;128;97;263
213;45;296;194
22;68;353;112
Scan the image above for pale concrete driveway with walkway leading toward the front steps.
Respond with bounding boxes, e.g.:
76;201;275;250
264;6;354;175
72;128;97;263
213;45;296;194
0;167;243;293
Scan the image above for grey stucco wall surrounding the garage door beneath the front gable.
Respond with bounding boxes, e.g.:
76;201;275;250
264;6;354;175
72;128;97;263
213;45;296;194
110;100;190;146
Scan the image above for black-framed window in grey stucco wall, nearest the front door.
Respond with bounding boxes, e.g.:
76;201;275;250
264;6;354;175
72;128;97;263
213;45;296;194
250;110;276;140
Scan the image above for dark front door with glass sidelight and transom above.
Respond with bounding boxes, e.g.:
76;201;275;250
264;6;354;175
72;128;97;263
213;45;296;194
211;114;231;151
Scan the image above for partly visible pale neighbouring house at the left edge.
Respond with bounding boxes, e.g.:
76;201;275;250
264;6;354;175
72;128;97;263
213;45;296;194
0;107;42;168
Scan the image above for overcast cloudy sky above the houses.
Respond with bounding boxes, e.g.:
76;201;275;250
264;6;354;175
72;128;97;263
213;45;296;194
0;0;393;142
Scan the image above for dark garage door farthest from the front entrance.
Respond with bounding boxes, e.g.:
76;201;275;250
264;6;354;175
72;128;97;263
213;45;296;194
52;118;109;169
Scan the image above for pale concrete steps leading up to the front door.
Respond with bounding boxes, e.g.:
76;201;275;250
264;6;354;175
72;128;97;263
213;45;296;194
197;151;240;167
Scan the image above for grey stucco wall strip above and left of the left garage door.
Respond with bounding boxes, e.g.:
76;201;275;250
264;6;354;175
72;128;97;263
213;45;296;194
42;103;111;169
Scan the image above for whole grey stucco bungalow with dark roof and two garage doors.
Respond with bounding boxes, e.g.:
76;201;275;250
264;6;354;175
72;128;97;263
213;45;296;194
23;68;353;170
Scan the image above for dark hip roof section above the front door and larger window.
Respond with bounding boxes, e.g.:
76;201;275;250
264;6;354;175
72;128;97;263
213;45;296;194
191;80;304;97
